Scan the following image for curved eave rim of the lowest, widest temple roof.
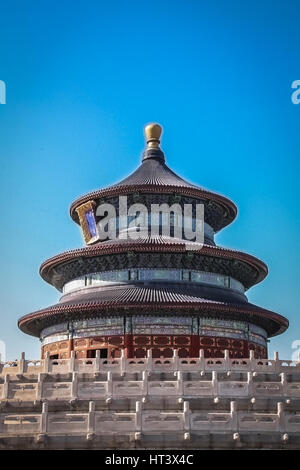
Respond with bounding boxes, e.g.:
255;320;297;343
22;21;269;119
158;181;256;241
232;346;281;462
18;293;289;337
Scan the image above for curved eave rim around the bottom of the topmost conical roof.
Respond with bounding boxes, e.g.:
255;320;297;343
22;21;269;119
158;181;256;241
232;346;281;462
70;184;237;228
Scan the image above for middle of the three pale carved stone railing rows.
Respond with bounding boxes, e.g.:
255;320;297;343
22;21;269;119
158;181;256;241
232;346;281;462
0;371;300;402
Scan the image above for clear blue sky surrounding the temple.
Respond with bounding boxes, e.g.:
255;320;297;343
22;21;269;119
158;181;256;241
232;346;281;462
0;0;300;359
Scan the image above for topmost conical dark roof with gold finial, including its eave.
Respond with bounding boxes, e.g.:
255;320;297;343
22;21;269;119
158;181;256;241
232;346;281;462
70;124;237;228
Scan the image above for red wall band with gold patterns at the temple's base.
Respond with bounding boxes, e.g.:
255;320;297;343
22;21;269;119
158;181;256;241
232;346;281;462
42;332;267;358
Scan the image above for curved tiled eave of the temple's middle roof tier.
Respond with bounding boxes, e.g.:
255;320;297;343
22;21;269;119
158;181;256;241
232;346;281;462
40;239;268;284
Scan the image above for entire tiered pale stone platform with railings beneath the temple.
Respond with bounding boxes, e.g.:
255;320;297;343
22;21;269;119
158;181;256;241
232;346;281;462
0;351;300;449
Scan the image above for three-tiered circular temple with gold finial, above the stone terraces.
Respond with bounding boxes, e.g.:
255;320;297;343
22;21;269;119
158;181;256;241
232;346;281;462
19;124;288;359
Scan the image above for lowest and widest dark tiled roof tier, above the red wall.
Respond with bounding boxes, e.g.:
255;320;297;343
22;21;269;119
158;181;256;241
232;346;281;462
19;284;288;336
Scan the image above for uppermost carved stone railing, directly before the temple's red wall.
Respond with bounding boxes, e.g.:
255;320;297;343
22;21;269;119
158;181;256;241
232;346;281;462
0;350;300;377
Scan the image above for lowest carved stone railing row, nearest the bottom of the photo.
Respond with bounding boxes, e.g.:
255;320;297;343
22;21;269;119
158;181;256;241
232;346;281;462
0;401;300;440
